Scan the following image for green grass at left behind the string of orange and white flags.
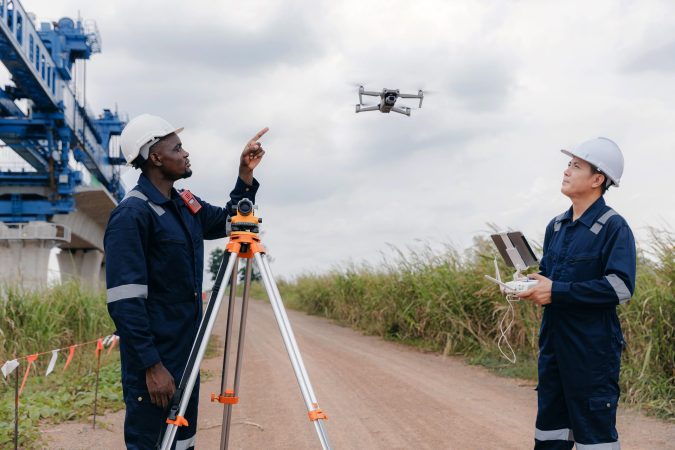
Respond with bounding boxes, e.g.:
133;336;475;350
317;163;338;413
0;283;124;448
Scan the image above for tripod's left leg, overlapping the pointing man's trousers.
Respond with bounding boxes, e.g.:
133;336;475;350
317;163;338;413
161;253;238;450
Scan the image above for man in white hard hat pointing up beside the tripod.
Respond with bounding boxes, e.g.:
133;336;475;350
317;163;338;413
104;114;267;449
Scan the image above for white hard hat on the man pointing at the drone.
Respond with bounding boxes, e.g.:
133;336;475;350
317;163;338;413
120;114;183;164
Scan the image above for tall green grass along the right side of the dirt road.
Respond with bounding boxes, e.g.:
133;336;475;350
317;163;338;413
279;231;675;420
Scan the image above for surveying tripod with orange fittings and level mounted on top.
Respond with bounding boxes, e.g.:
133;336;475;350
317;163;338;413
160;199;331;450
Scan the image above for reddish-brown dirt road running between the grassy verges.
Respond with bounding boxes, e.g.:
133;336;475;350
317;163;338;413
44;301;675;450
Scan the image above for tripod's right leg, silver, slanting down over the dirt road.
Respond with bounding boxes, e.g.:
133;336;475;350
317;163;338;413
254;253;331;450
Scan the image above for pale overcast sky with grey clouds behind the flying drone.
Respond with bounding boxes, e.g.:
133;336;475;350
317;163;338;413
9;0;675;277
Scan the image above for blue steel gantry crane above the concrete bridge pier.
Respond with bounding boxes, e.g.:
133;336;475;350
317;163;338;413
0;0;124;286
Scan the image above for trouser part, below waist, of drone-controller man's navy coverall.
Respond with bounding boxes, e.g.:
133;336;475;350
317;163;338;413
534;307;622;450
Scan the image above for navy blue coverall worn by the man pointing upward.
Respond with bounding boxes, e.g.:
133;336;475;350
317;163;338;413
104;174;258;450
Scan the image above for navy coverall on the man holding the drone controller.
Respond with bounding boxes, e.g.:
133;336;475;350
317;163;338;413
535;197;636;450
